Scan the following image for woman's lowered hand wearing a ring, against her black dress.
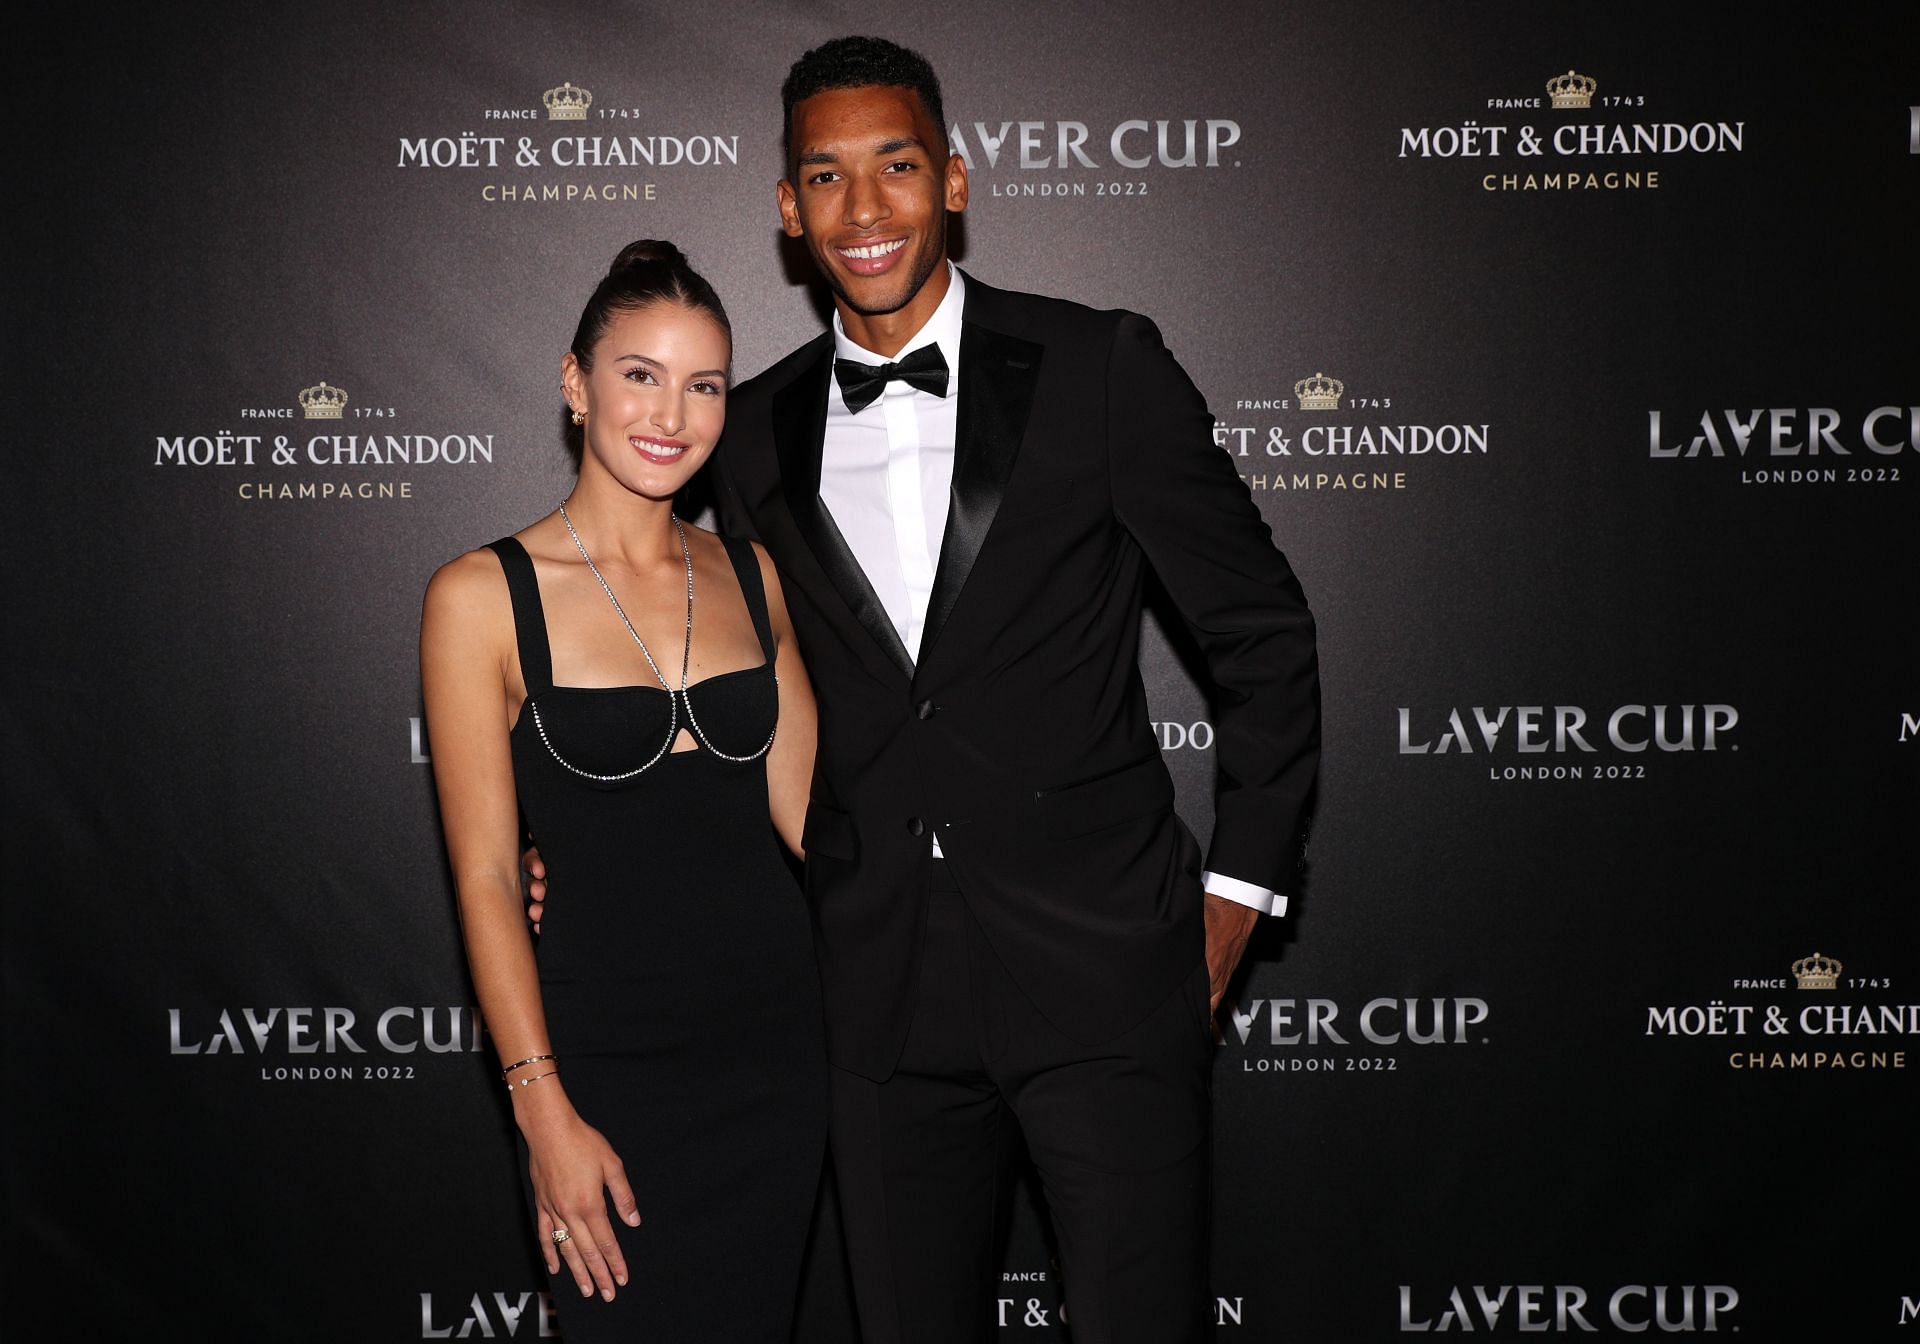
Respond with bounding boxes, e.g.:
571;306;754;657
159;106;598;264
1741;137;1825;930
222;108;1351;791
522;1105;639;1302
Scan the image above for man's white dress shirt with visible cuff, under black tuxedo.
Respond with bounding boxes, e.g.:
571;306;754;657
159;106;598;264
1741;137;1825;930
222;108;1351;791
820;263;1286;914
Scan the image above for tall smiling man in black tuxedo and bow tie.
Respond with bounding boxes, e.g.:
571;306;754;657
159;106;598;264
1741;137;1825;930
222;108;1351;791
541;38;1319;1344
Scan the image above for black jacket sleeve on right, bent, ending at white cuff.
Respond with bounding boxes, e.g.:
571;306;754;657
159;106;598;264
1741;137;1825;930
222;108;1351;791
1106;313;1319;893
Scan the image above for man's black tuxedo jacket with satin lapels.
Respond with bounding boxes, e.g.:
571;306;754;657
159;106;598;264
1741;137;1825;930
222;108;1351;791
714;276;1319;1079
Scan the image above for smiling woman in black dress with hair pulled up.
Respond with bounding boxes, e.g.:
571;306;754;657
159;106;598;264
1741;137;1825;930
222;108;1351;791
420;242;826;1344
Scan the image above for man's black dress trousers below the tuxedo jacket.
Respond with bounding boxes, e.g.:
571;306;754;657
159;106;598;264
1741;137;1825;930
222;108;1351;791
831;860;1213;1344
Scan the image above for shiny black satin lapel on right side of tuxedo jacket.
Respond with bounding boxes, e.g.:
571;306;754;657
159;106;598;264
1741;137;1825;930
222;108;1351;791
920;320;1043;675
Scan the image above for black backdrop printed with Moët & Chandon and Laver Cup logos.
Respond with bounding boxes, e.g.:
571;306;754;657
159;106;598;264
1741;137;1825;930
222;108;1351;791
15;0;1920;1344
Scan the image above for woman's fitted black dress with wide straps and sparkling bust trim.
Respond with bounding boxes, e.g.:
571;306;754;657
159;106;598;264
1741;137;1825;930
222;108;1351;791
493;538;826;1344
